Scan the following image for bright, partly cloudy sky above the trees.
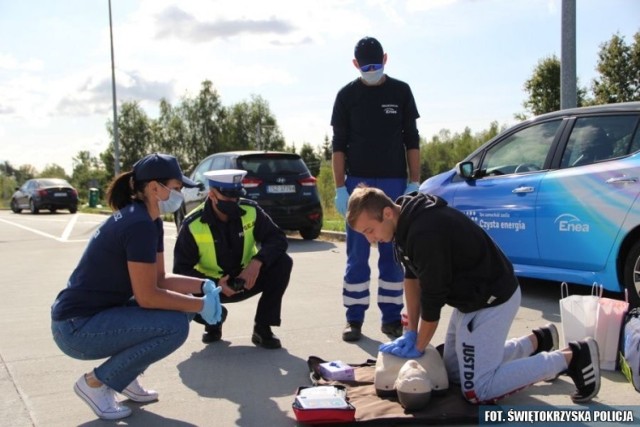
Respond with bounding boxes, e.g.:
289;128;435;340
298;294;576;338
0;0;640;173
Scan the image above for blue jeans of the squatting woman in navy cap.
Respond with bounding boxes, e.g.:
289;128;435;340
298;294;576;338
51;305;194;392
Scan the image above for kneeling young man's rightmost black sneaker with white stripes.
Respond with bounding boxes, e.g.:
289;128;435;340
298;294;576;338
567;337;600;403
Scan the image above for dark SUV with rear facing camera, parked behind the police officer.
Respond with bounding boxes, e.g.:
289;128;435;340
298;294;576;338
174;151;322;240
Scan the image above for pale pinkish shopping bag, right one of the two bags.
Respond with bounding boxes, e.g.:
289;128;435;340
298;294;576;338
594;292;629;371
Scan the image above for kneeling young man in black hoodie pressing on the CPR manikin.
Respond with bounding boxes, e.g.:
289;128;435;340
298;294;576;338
347;186;600;404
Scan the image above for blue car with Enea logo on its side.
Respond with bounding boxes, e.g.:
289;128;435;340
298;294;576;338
420;102;640;305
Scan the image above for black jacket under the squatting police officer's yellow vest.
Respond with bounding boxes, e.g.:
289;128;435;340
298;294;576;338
173;199;289;279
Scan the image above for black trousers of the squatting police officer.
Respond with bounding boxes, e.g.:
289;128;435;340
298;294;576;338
194;253;293;330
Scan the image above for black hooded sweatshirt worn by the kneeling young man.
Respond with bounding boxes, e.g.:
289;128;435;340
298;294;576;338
395;192;518;321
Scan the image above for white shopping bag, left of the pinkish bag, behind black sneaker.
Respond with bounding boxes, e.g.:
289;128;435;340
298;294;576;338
560;282;602;346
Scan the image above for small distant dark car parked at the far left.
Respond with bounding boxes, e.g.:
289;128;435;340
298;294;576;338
11;178;78;214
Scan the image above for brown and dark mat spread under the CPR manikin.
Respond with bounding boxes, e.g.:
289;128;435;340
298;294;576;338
307;356;479;426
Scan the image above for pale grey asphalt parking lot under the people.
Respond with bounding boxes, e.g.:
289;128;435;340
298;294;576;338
0;211;640;427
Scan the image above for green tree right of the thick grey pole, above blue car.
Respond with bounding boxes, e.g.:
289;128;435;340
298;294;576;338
593;32;640;104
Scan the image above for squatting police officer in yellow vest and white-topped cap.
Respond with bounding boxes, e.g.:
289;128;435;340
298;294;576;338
173;169;293;349
